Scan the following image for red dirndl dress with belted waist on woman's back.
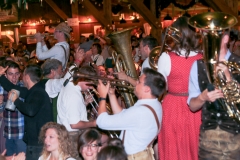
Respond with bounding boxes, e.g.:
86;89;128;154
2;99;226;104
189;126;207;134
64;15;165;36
158;52;202;160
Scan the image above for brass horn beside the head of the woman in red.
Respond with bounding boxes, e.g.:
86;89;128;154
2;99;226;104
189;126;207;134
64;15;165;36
149;27;181;70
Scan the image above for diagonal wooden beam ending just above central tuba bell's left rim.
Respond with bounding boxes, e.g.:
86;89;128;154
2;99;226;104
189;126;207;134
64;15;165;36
82;0;112;28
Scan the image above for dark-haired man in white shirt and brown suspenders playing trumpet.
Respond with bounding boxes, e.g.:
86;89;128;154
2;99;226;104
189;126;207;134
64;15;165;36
96;68;166;160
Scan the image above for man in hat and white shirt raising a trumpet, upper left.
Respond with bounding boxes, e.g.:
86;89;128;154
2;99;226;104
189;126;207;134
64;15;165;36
35;22;71;70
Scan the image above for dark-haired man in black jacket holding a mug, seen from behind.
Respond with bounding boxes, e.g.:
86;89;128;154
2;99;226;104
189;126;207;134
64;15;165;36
0;65;53;160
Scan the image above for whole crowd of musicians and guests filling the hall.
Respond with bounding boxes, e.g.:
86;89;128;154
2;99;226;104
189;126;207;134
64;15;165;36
0;12;240;160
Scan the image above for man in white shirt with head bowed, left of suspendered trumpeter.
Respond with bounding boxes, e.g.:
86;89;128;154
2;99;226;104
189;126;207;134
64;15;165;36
57;66;96;159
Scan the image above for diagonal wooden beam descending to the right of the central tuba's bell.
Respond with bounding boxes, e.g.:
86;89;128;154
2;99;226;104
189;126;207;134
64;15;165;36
128;0;161;28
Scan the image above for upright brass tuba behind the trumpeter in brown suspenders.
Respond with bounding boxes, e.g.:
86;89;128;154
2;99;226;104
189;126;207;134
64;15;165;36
108;27;138;108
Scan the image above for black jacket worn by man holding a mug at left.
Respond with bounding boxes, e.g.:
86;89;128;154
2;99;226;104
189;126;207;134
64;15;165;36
0;76;53;146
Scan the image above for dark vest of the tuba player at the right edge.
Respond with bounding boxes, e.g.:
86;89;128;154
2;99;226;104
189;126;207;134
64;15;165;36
197;54;240;134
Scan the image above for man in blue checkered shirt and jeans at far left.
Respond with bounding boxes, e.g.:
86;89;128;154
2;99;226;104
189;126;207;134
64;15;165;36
1;61;26;156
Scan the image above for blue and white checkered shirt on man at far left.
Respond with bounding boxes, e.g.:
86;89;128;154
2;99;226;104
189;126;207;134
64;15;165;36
0;82;24;139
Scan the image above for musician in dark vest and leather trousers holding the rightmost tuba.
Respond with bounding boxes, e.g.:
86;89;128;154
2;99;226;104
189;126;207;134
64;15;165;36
188;30;240;160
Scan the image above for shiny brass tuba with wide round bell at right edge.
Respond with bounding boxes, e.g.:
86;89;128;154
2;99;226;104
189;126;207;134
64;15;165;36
189;12;240;121
